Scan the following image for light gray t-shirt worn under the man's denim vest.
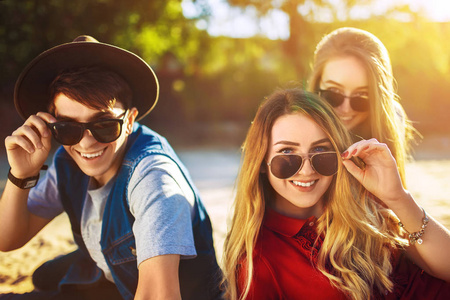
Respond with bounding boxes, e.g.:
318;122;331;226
28;155;197;281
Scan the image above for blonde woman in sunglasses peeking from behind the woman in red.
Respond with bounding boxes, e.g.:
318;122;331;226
308;27;415;183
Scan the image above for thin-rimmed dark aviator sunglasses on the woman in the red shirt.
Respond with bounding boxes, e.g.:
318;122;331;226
267;152;338;179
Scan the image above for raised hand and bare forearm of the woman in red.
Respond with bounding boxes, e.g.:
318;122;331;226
343;139;450;281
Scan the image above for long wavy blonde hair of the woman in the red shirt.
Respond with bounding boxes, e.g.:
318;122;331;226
223;89;404;300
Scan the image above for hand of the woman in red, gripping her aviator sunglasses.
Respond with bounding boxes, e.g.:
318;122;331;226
342;139;407;206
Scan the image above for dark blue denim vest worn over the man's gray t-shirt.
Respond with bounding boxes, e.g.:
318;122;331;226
54;124;221;299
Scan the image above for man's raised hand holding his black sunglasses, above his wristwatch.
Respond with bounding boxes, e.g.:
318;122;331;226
5;112;56;178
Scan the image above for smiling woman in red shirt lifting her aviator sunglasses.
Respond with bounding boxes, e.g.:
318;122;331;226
223;89;450;300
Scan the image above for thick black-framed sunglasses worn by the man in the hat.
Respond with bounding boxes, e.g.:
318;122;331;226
47;110;128;146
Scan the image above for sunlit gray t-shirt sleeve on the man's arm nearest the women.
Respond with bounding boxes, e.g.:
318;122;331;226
128;155;197;265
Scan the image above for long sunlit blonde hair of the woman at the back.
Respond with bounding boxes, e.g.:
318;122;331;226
308;27;417;185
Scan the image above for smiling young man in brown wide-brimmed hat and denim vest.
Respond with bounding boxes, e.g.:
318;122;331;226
0;36;221;299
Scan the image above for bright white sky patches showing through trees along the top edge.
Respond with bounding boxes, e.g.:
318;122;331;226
182;0;450;40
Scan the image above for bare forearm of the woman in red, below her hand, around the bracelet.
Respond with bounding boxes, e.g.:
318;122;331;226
389;192;450;281
